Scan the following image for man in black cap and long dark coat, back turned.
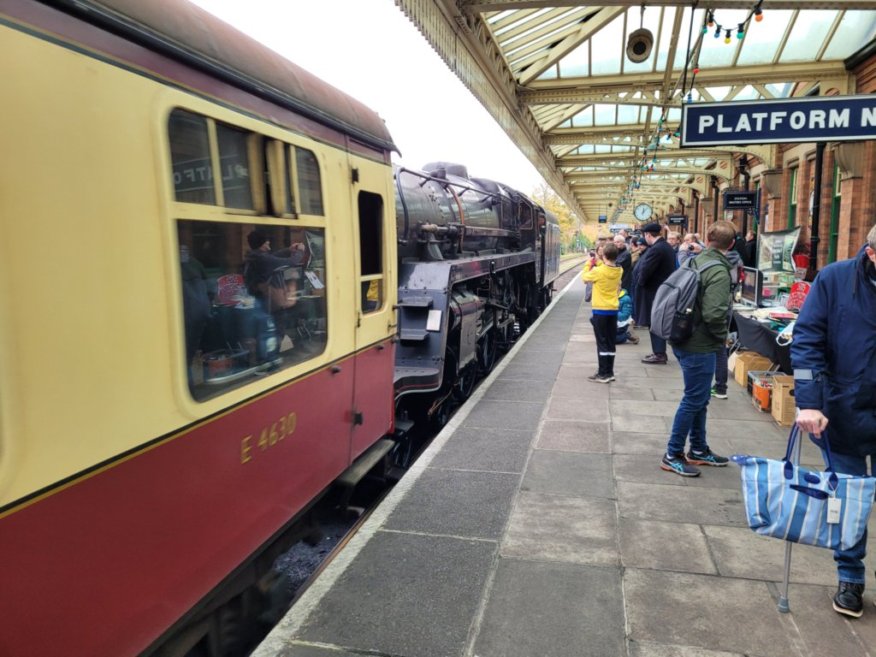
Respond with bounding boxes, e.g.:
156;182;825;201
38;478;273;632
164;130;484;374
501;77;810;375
633;223;675;365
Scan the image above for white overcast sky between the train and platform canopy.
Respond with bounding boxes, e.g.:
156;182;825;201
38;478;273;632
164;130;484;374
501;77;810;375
192;0;543;194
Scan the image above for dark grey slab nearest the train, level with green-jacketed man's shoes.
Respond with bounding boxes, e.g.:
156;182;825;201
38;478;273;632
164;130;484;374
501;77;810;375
429;427;532;473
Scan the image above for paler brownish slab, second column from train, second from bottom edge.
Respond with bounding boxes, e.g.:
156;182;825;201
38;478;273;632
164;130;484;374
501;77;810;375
500;492;620;566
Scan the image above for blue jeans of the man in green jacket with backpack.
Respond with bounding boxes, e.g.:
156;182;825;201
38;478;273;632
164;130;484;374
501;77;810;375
666;347;715;456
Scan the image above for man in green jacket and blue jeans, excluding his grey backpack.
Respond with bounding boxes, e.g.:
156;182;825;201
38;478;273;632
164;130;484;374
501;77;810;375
660;221;736;477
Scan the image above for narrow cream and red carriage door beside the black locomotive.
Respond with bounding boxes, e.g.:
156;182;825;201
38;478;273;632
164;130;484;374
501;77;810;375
351;174;395;459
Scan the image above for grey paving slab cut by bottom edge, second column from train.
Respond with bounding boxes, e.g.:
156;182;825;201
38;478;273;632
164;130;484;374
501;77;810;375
473;559;626;657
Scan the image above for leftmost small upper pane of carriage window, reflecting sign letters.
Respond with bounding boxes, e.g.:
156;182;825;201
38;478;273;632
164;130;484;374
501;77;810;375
168;110;216;204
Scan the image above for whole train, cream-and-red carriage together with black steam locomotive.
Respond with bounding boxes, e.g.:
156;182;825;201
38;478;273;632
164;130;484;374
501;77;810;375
0;0;558;657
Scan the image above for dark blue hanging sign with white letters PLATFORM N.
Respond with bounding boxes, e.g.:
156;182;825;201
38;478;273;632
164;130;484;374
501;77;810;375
681;95;876;147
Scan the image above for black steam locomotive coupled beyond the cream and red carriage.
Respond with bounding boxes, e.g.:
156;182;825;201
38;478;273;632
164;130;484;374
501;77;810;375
394;162;560;424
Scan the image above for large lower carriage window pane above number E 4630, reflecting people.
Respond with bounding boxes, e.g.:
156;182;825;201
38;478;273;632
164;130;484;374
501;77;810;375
177;220;328;401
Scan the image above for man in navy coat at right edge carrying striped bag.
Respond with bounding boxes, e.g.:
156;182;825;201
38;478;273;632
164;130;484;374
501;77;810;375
791;226;876;618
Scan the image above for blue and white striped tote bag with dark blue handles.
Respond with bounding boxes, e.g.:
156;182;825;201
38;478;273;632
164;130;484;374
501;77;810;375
732;425;876;550
